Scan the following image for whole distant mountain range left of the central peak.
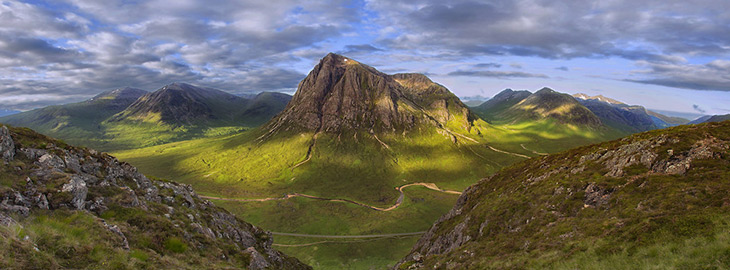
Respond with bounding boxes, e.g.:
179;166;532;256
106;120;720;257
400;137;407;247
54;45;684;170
0;83;291;150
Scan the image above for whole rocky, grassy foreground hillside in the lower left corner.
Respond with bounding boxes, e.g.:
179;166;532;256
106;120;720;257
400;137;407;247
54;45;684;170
0;126;311;269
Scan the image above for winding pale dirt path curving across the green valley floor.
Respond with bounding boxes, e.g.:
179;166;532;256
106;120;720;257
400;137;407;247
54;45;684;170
200;183;461;212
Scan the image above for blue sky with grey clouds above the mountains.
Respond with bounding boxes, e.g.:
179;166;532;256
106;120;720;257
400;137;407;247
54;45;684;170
0;0;730;114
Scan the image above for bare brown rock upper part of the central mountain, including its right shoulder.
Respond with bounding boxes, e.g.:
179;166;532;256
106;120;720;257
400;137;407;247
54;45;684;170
267;53;468;136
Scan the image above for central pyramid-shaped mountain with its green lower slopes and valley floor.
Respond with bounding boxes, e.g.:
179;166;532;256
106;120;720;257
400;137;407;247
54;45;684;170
109;55;615;269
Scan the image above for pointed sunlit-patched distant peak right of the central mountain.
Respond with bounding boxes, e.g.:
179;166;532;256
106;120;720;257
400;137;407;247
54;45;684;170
502;88;601;127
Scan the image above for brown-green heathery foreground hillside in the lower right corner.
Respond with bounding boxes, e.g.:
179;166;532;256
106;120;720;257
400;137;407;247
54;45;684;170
396;121;730;269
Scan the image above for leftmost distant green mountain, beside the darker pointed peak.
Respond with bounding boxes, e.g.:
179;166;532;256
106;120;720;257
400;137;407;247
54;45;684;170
0;87;147;147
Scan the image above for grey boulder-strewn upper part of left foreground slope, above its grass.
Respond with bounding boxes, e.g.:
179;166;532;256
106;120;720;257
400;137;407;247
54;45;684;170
0;126;309;269
